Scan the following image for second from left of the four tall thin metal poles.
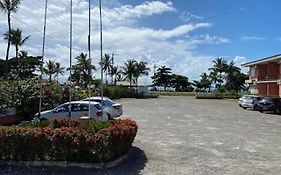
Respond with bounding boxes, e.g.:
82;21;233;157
68;0;72;118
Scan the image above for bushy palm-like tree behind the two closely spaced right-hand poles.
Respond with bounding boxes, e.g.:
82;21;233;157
70;53;96;88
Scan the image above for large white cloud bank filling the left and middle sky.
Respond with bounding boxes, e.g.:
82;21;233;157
0;0;230;84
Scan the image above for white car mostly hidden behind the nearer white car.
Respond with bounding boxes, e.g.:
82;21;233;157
83;97;123;119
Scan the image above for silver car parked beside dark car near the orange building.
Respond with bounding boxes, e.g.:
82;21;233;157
238;95;264;110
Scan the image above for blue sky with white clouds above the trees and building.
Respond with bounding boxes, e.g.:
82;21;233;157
0;0;281;84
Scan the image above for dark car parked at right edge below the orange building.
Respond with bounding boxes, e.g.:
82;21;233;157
257;97;281;114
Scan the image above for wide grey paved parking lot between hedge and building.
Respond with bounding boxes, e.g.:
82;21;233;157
0;97;281;175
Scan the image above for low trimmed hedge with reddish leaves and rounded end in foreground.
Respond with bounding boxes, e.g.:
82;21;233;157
0;119;138;163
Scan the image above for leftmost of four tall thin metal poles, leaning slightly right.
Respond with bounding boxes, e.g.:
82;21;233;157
38;0;48;119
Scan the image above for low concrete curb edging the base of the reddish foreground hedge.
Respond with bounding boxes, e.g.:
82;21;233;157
0;151;130;169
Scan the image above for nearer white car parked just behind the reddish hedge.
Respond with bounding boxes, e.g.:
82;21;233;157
35;101;108;121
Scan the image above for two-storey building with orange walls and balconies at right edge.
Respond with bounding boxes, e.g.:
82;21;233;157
242;54;281;97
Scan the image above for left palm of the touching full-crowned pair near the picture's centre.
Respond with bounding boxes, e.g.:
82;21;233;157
122;60;136;88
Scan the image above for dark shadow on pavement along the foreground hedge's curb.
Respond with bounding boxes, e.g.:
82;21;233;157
0;147;147;175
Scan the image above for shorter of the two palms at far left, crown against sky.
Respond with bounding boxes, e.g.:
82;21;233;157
4;28;30;58
